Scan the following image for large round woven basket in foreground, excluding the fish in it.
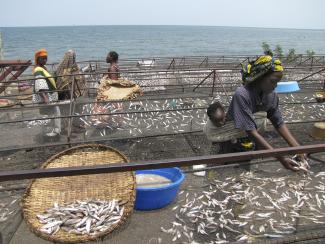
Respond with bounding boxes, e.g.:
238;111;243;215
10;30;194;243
22;144;135;243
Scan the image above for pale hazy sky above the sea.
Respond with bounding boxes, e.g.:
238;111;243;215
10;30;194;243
0;0;325;29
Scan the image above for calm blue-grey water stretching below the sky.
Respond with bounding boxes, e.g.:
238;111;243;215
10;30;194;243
0;26;325;62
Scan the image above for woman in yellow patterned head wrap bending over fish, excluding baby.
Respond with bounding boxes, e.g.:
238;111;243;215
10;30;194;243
227;55;305;171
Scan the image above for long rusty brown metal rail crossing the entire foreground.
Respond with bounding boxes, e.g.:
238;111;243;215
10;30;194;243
0;144;325;182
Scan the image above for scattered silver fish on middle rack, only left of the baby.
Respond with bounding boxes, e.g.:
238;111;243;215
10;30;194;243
77;98;207;136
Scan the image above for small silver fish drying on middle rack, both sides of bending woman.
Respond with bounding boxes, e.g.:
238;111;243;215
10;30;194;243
76;90;325;137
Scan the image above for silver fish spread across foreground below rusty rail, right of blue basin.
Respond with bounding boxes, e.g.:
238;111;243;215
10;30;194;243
161;172;325;243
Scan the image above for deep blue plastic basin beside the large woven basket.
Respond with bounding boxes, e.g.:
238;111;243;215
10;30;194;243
134;168;185;210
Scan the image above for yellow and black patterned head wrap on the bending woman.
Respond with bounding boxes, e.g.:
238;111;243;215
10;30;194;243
241;55;283;85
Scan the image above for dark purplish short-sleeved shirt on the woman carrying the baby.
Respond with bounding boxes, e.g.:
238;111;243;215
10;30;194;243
227;86;284;131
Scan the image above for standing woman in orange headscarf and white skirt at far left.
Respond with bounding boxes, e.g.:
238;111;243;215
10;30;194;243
33;49;61;136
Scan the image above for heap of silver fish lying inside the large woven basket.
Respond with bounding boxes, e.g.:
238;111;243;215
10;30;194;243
37;199;124;235
